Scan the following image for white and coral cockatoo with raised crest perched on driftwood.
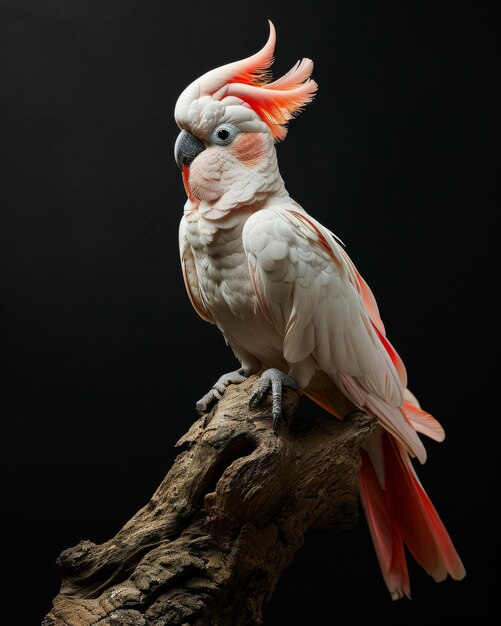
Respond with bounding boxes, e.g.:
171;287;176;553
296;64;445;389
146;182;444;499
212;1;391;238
175;22;465;599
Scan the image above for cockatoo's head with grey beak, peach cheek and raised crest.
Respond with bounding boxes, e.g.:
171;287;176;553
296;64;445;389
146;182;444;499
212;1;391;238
174;22;317;219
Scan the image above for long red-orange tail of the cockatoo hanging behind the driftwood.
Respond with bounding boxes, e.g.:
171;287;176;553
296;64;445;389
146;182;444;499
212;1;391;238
359;428;466;600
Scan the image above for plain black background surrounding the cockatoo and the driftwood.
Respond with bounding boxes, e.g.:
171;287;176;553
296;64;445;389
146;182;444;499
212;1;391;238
0;0;499;626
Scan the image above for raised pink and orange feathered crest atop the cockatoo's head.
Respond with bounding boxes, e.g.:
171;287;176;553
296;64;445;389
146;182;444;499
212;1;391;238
178;21;317;141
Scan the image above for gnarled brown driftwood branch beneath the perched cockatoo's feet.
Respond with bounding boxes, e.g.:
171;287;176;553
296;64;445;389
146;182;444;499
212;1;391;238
43;377;374;626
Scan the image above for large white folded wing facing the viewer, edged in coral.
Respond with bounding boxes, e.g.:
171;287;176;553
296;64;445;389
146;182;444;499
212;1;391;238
243;205;426;462
